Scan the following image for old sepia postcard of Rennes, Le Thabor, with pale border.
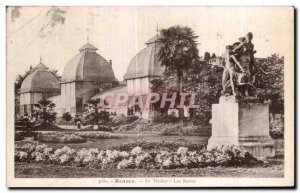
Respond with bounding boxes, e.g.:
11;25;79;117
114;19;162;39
6;6;295;187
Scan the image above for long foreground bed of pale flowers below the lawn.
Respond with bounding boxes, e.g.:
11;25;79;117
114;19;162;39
15;143;262;169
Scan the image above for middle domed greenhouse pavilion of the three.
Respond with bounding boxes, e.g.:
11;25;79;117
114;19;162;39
58;43;116;115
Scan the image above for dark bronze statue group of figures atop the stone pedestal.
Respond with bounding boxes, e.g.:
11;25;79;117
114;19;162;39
222;32;266;97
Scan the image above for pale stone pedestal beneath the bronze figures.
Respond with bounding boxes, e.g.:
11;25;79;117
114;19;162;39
207;98;275;157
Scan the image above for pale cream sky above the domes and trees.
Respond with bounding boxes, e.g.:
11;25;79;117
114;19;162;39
6;7;294;81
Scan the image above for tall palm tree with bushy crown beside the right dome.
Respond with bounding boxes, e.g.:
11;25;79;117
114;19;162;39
158;25;199;120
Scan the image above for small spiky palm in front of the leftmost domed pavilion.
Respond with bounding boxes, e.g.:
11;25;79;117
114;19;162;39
34;99;57;123
